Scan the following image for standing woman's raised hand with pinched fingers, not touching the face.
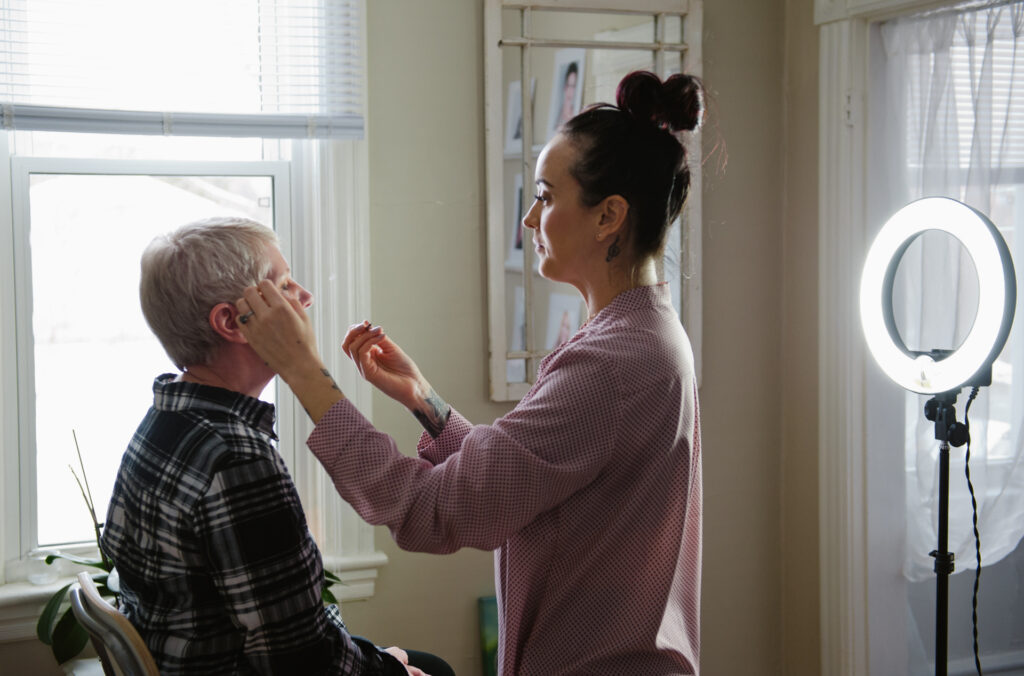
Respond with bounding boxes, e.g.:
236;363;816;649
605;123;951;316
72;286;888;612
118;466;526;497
341;322;430;410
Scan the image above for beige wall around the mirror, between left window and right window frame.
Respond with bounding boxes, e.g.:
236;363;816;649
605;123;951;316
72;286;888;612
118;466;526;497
0;0;818;676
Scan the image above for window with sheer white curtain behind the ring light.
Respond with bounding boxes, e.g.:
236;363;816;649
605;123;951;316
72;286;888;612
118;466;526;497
865;2;1024;673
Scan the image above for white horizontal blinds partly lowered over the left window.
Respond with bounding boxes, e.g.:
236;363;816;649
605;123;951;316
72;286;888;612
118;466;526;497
0;0;364;138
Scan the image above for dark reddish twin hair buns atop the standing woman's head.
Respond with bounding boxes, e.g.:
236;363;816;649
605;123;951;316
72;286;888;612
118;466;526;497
615;71;703;131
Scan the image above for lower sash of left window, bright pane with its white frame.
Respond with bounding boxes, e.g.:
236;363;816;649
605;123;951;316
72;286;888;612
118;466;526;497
11;157;291;550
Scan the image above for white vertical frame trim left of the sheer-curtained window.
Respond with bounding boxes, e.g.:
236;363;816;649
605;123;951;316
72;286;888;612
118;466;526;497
814;0;978;676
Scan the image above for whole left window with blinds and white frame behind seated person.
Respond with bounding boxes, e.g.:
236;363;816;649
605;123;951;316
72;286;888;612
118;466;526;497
0;0;386;622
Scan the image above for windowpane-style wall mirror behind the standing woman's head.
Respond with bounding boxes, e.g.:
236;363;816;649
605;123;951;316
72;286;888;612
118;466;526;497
484;0;701;400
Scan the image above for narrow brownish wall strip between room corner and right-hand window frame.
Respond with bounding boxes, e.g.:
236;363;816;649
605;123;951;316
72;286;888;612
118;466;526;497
779;0;821;676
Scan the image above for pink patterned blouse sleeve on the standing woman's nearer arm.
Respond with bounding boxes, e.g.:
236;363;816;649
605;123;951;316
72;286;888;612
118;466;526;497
307;349;623;553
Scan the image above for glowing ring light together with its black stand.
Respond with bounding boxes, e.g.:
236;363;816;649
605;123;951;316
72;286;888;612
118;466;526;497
860;198;1017;676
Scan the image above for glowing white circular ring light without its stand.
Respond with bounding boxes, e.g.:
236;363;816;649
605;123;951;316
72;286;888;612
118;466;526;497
860;198;1017;394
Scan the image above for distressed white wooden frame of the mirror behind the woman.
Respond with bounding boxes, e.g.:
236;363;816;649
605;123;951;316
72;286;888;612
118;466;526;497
483;0;703;402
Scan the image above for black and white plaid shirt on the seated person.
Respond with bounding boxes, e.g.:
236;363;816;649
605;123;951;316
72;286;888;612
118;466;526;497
102;374;395;676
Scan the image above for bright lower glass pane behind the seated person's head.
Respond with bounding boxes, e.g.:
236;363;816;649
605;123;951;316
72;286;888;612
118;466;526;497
30;174;273;546
